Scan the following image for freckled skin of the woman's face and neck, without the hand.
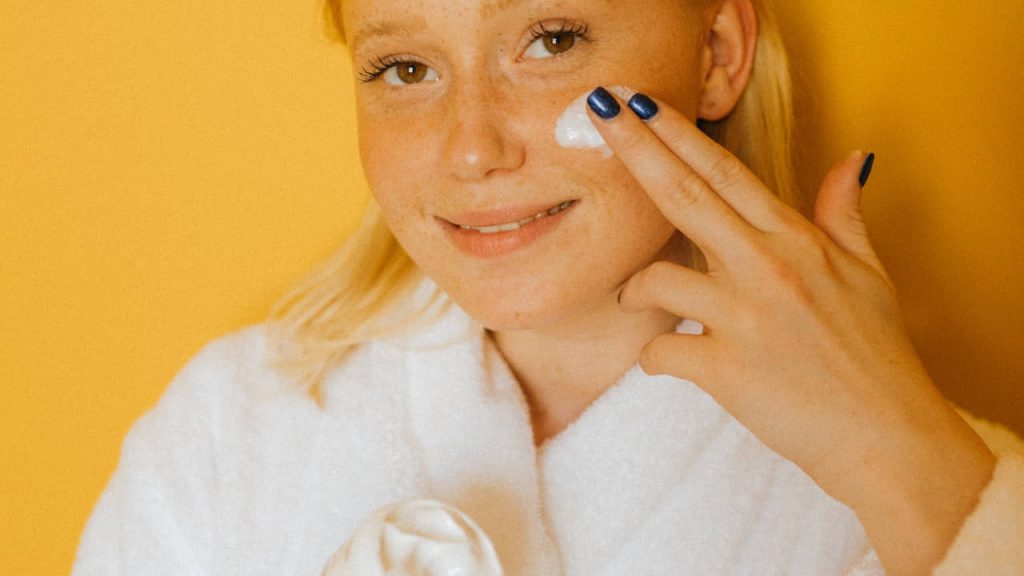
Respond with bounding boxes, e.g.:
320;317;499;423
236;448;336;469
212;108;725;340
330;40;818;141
343;0;716;434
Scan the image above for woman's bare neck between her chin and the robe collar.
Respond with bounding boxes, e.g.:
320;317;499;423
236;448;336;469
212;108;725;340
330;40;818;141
494;294;679;445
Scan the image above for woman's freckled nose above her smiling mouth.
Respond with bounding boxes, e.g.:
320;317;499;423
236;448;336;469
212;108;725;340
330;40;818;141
444;77;525;180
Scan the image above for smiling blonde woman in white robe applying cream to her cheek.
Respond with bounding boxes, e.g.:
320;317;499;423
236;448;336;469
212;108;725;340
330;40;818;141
76;0;1024;575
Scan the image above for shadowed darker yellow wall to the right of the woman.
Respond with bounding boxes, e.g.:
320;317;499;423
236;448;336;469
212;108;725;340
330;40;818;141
783;0;1024;433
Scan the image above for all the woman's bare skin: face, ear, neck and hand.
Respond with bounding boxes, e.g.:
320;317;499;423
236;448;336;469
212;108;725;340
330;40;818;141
343;0;993;574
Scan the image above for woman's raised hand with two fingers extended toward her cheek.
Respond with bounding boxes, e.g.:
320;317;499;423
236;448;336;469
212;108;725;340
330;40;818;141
593;86;994;574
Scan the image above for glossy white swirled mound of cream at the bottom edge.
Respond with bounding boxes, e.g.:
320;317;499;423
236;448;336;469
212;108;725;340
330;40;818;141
323;499;504;576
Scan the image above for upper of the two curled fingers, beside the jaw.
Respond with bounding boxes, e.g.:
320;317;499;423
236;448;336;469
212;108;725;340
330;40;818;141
618;261;720;324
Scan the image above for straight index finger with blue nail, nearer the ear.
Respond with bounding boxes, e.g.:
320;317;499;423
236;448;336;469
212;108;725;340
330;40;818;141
629;93;796;232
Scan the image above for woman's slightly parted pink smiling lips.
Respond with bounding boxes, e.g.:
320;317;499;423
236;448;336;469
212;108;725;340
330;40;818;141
436;200;580;259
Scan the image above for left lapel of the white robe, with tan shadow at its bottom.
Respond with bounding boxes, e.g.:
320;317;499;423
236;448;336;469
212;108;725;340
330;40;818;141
401;305;560;576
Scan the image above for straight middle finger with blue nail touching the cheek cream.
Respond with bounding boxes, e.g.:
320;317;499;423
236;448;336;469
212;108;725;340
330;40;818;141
589;88;757;257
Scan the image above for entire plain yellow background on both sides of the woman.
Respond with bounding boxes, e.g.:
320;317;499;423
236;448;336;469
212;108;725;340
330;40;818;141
0;0;1024;575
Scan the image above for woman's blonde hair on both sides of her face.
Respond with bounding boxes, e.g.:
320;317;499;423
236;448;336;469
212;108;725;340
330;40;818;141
269;0;798;389
